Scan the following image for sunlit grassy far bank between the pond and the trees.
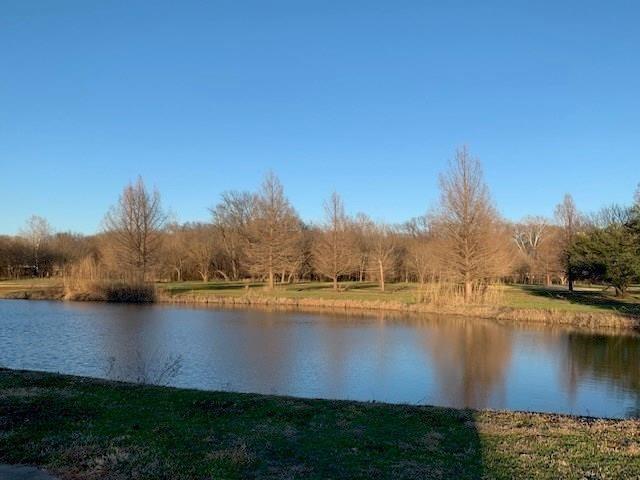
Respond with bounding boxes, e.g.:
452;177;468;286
0;280;640;329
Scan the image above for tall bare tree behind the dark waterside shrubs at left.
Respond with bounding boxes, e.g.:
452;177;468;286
104;177;166;281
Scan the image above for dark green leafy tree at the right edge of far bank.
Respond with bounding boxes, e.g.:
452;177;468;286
569;207;640;296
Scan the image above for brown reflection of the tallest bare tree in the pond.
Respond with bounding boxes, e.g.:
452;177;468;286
427;318;512;408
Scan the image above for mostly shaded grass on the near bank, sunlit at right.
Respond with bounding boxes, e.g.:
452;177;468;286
0;370;640;479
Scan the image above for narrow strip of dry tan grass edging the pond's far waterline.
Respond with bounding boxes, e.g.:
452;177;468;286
0;288;640;331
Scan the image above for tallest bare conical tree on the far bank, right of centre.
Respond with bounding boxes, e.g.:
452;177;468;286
436;147;502;301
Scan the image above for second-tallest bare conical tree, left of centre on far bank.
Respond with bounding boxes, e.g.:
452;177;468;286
247;173;300;289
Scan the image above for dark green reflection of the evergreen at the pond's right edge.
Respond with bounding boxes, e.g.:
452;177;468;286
566;333;640;413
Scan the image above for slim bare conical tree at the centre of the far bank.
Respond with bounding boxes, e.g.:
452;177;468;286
313;192;354;290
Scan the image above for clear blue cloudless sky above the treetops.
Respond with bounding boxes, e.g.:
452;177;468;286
0;0;640;234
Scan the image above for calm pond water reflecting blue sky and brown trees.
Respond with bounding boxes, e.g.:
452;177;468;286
0;300;640;417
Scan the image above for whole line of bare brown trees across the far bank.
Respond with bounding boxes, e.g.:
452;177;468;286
0;148;640;300
